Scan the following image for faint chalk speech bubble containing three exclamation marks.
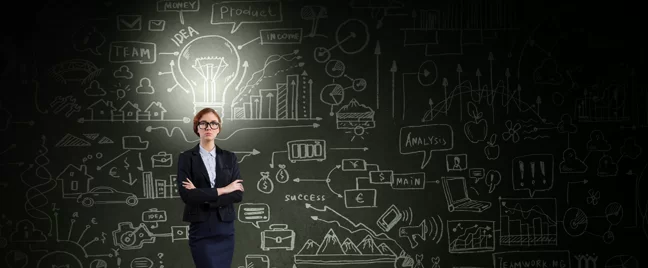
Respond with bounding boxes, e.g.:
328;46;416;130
511;154;554;197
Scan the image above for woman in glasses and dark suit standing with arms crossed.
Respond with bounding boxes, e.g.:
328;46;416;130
177;108;243;268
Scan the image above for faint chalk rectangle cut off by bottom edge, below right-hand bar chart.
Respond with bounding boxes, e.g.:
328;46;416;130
493;250;571;268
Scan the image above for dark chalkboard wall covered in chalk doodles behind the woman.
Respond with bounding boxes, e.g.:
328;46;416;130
0;0;648;268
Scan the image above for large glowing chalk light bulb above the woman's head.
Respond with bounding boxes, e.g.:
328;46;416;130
178;35;240;116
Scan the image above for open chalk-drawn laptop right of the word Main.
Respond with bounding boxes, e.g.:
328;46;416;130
441;177;491;212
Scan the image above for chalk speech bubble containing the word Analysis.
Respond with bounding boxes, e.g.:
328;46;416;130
398;124;454;169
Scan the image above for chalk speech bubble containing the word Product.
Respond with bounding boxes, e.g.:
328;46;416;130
211;1;283;33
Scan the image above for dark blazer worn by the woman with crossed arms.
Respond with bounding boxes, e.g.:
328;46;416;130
176;144;243;222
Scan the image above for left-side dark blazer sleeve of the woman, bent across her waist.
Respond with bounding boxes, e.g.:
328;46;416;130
176;152;219;206
